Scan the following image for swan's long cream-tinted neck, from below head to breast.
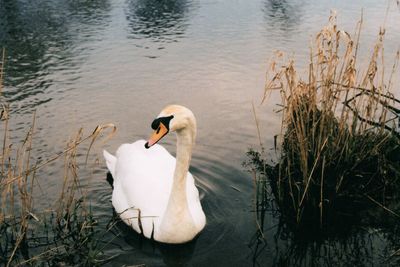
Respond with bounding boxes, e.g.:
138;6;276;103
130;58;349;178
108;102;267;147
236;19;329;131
160;128;197;243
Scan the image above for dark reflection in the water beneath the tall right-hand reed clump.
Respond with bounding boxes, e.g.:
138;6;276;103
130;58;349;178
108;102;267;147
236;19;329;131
247;153;400;266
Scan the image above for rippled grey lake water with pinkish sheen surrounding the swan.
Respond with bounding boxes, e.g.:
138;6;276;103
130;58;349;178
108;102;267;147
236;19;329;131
0;0;400;266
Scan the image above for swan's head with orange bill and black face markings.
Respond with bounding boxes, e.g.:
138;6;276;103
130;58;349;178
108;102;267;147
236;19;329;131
144;105;196;148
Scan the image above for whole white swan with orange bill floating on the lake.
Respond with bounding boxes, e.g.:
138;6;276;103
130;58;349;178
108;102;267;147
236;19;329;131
103;105;206;244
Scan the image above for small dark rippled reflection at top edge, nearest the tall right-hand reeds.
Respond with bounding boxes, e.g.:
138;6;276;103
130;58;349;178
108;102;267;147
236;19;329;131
264;0;303;32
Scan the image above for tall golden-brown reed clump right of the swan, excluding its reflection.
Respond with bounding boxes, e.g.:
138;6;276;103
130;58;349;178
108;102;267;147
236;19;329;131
256;14;400;232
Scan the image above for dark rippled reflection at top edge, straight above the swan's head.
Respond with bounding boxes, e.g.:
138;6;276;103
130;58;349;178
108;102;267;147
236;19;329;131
126;0;189;42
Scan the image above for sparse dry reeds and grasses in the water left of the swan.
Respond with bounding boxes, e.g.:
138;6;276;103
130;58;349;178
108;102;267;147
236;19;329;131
0;50;116;267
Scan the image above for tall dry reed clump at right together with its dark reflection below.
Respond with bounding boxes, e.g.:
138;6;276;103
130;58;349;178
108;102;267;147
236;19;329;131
245;9;400;266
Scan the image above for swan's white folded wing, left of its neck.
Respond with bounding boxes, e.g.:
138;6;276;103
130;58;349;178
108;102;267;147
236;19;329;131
112;140;175;237
